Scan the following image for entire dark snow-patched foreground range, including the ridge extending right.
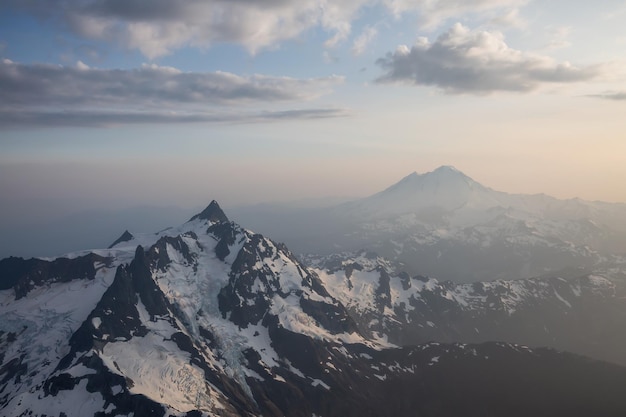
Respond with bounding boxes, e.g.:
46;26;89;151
0;200;626;417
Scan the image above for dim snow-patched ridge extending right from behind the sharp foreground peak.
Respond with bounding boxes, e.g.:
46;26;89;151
307;252;626;365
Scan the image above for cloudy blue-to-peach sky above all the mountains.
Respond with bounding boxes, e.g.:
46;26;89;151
0;0;626;240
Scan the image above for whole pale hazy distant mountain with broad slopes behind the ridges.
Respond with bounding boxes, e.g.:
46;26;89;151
232;166;626;282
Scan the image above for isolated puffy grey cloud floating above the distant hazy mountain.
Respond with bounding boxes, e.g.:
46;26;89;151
376;23;603;94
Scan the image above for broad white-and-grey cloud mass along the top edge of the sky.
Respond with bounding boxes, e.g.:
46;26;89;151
8;0;528;59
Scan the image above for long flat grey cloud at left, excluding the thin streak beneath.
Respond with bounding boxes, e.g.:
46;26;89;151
0;60;342;106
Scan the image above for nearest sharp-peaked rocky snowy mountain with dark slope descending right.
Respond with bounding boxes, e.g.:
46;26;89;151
0;202;626;417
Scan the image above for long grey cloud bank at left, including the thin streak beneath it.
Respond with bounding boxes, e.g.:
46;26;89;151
0;59;343;126
